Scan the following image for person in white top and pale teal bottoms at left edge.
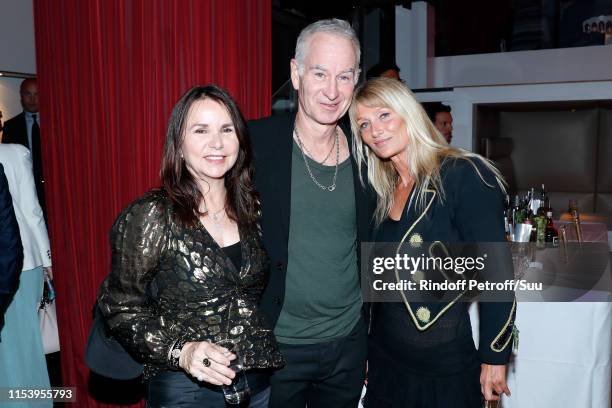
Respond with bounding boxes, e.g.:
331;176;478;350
0;144;53;407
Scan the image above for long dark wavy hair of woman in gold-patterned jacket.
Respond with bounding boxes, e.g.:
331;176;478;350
160;85;259;228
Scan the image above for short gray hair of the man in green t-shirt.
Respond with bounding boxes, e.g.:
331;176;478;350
295;18;361;74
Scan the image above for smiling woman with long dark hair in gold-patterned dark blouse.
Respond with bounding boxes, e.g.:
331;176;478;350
98;85;283;407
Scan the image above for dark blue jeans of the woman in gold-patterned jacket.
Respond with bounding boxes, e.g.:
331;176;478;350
147;371;270;408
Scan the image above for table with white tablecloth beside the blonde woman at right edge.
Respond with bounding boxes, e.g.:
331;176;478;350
478;224;612;408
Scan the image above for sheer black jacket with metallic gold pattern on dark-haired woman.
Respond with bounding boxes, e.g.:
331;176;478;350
98;190;283;379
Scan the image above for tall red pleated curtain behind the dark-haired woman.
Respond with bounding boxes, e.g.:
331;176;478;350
34;0;272;407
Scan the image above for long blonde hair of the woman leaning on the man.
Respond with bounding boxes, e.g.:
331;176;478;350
349;78;506;225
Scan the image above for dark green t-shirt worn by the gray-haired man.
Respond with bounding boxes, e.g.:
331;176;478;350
274;142;362;344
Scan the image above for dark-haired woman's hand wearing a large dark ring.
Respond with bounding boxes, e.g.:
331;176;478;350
179;341;236;385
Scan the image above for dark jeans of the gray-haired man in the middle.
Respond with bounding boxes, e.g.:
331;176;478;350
270;319;367;408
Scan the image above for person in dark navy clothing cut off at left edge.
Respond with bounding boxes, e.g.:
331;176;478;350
0;164;23;334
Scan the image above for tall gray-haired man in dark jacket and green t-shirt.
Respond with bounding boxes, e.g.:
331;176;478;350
249;19;370;408
